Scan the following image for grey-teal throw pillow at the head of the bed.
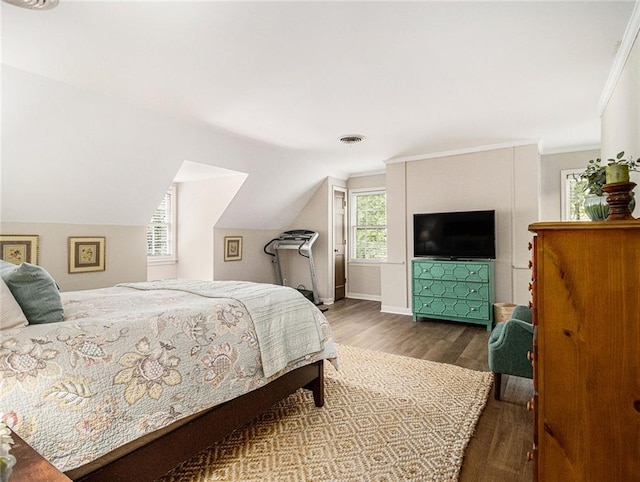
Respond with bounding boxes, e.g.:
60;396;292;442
0;261;64;325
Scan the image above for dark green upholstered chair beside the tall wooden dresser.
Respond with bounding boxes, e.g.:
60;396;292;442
489;305;533;400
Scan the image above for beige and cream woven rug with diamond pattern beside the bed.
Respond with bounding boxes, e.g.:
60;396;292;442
162;345;491;482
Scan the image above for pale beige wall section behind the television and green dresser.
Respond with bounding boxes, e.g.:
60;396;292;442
382;144;540;313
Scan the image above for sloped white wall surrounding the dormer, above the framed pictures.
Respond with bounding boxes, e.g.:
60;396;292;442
0;64;336;233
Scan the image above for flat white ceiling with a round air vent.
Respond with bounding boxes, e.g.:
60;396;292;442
2;0;635;175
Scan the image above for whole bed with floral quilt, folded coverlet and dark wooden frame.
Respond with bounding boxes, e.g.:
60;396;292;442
0;275;337;481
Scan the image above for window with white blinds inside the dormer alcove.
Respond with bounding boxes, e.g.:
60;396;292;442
147;186;175;260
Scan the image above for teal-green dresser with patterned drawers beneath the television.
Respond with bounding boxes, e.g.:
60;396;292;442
412;259;493;331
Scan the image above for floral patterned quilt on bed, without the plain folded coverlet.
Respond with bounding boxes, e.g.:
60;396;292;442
0;282;337;471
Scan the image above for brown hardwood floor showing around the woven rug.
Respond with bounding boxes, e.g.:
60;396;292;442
325;299;533;482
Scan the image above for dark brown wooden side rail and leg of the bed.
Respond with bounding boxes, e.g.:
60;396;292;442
67;360;324;482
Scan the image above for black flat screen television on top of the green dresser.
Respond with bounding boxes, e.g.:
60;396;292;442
413;210;496;259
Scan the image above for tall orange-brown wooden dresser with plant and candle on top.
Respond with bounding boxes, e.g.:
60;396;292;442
529;221;640;482
